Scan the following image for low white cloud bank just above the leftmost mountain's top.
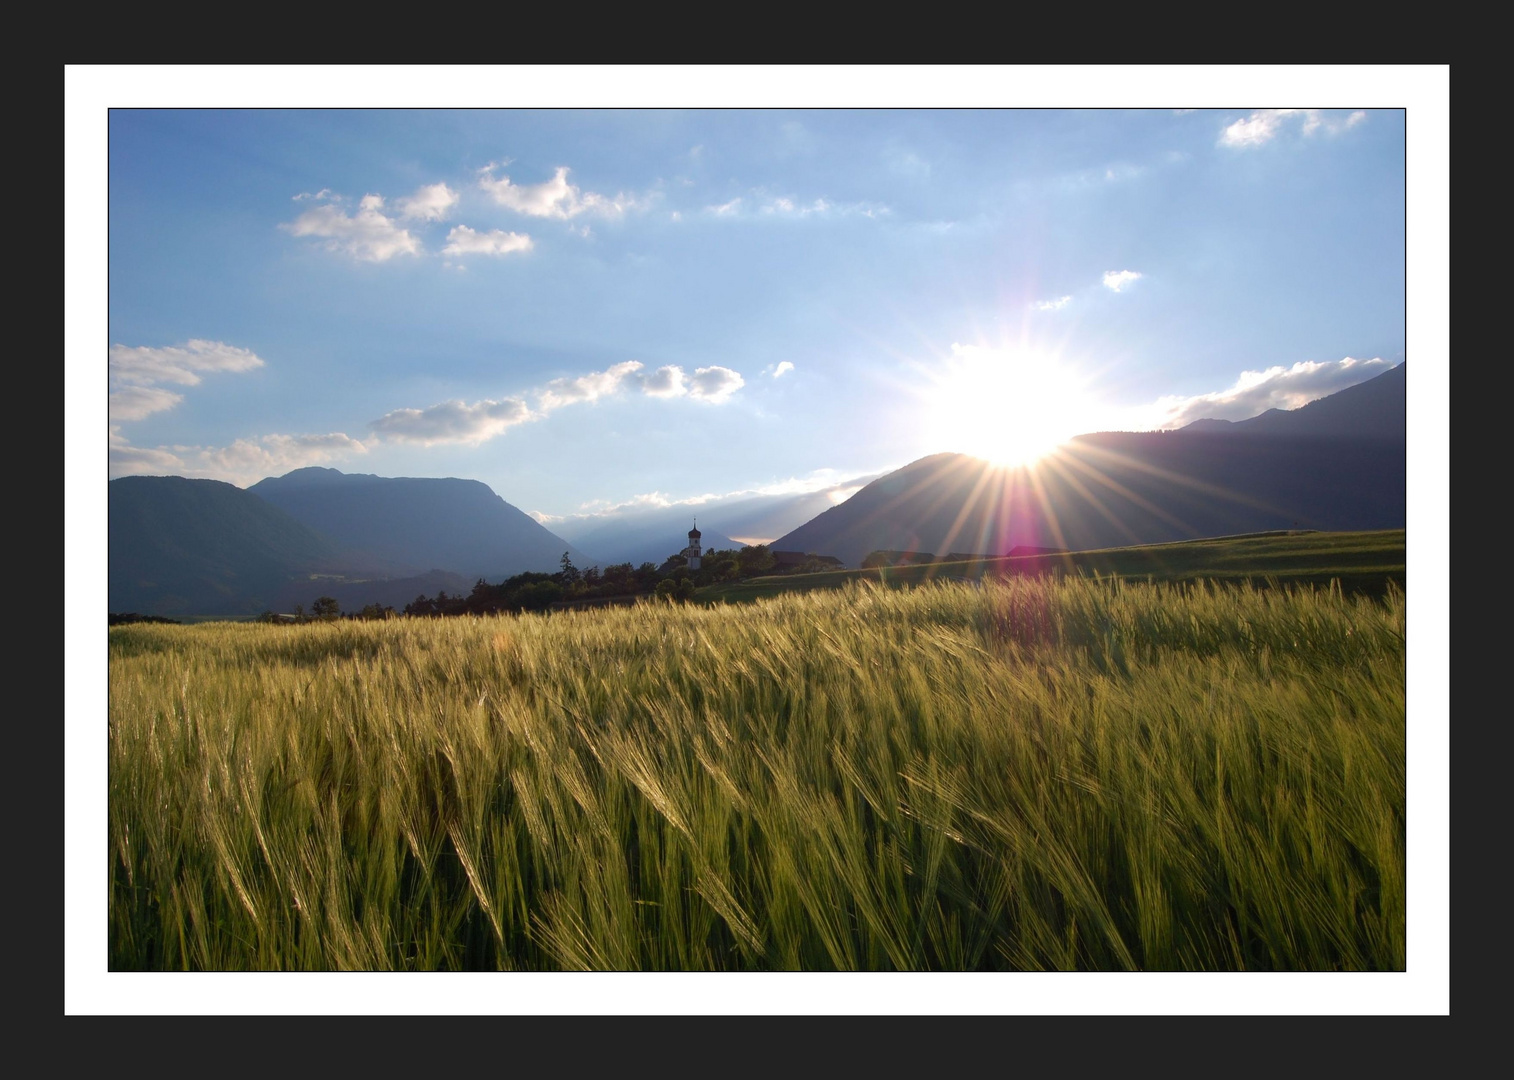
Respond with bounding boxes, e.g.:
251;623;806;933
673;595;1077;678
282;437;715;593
111;427;368;486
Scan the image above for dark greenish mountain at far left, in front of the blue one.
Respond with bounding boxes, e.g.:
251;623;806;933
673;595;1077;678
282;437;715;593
106;476;352;615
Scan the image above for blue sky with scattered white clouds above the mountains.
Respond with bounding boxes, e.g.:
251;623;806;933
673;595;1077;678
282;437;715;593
107;86;1405;523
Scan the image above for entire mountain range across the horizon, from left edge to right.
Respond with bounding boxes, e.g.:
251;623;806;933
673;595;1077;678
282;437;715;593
107;365;1407;616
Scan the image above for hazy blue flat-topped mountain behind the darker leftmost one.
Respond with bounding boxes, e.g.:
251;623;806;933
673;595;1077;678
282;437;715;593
247;467;593;581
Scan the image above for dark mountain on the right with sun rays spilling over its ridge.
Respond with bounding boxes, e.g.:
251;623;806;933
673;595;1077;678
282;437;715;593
772;365;1407;567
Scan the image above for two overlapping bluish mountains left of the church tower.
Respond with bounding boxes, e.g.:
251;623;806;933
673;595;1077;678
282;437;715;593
107;468;592;616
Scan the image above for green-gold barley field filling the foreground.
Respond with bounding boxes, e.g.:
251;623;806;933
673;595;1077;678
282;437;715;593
109;577;1405;971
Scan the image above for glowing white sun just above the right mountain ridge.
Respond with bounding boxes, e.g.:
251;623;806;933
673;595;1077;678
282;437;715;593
925;345;1095;467
